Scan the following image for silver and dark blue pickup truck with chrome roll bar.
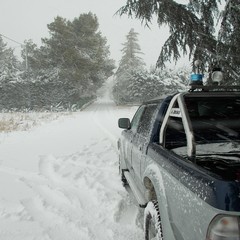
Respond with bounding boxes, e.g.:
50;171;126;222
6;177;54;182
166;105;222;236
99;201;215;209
118;86;240;240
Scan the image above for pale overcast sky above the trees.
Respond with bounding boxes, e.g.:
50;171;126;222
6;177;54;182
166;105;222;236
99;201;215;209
0;0;178;66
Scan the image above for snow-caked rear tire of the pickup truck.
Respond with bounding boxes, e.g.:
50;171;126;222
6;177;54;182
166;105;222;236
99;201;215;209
144;201;163;240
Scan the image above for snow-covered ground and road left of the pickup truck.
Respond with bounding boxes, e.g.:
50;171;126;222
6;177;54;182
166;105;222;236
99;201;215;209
0;79;143;240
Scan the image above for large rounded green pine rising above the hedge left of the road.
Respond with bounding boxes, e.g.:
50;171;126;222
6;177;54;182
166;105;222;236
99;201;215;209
42;13;114;95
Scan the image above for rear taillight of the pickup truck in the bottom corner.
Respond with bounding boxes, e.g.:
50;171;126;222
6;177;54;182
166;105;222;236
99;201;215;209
206;215;240;240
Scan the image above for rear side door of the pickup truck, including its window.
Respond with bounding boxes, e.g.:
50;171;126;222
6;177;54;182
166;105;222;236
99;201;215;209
131;104;157;185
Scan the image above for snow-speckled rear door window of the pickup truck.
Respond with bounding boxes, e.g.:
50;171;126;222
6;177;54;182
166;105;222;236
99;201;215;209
137;104;157;137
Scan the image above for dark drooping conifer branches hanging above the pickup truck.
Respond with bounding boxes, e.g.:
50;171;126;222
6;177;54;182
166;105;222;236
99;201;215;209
119;0;240;84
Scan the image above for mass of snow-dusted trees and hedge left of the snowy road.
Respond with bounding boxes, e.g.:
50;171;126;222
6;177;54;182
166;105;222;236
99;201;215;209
0;13;115;111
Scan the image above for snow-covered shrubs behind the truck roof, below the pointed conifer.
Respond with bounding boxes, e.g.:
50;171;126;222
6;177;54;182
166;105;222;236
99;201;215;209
113;68;190;104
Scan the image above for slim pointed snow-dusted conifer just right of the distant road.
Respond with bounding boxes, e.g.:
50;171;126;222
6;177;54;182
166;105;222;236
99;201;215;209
113;28;145;103
